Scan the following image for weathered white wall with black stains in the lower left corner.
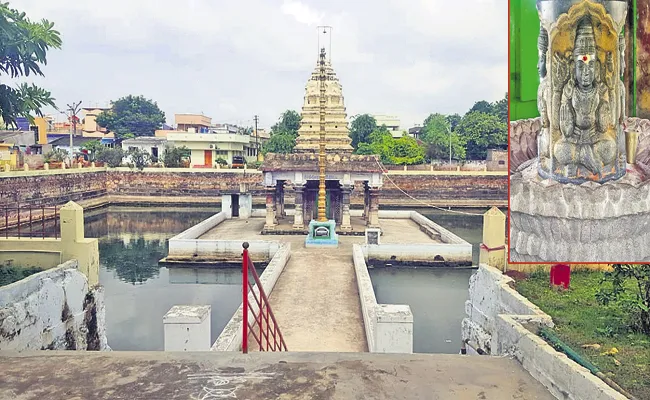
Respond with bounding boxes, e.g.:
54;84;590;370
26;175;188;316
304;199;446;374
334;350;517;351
0;260;107;351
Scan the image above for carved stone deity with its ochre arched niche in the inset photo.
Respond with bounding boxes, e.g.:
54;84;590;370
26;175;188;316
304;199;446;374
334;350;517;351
537;0;626;184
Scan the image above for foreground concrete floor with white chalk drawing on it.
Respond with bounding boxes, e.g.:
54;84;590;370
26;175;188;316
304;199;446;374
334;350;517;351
0;351;553;400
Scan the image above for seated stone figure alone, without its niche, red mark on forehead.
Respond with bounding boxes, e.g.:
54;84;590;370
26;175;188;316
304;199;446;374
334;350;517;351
553;18;617;179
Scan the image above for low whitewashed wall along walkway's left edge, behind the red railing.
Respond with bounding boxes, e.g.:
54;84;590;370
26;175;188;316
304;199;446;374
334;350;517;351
210;242;291;351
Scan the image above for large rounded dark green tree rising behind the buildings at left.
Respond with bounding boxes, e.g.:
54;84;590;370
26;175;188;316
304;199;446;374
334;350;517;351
96;95;165;139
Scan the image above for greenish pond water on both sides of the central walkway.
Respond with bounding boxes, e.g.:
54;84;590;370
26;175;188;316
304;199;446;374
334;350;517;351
85;207;494;353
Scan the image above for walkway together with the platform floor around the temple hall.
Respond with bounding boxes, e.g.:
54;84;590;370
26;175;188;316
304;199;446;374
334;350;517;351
200;217;440;352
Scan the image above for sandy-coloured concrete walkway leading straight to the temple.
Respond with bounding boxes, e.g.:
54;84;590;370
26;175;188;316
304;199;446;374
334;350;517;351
264;236;368;352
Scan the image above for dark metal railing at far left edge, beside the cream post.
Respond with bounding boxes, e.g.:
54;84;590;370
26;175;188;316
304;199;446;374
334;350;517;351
0;206;59;239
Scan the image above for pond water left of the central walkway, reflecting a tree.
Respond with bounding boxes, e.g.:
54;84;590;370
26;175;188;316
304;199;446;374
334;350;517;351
85;207;246;350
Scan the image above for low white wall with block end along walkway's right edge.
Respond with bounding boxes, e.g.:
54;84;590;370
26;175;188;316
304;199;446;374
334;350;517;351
352;244;413;353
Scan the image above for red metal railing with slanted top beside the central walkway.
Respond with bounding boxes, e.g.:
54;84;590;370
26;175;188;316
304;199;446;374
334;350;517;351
242;242;287;354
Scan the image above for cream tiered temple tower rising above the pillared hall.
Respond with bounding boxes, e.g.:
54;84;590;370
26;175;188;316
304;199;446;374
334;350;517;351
294;60;353;154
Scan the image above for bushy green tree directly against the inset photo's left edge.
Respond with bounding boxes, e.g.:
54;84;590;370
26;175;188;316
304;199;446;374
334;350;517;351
456;112;508;160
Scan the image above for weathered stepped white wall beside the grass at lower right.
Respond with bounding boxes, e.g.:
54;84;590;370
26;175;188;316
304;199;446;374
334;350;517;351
462;265;626;400
